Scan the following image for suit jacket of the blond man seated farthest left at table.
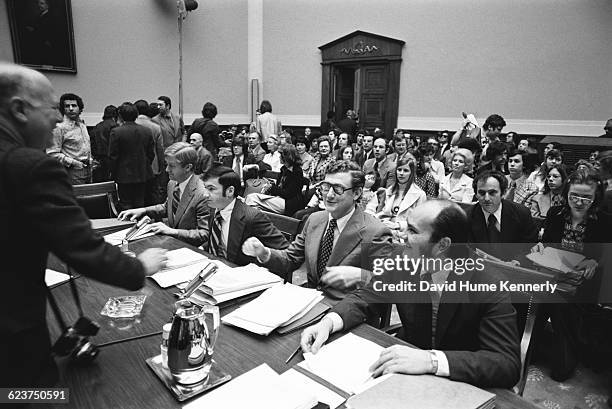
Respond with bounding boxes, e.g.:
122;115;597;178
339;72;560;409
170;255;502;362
145;175;210;247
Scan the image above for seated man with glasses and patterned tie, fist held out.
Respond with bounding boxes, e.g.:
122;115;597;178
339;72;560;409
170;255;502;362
242;161;391;299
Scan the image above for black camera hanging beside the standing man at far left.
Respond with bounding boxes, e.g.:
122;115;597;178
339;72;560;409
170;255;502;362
51;317;100;363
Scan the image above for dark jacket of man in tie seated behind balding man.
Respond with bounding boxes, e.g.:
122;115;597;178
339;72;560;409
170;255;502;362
468;199;538;260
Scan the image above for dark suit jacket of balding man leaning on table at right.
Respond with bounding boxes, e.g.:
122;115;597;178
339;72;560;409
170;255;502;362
332;270;521;388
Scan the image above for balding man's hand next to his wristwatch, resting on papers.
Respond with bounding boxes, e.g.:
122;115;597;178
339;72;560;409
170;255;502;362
370;345;433;378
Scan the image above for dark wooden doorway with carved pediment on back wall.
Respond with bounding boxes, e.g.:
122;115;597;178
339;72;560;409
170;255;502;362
319;31;405;137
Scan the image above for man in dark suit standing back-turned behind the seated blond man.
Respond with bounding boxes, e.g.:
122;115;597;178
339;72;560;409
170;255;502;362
108;102;155;210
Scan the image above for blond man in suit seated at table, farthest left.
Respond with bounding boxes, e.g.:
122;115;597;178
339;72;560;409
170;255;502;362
119;142;209;247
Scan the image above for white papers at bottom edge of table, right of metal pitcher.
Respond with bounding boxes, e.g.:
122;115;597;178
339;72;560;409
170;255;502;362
184;364;318;409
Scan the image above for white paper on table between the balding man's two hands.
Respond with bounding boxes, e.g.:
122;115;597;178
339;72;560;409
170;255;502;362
298;333;389;394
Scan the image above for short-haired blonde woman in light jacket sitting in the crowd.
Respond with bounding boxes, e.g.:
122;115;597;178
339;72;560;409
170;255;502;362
438;148;474;203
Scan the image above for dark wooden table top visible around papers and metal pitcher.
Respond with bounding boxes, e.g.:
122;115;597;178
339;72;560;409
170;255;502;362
45;236;536;409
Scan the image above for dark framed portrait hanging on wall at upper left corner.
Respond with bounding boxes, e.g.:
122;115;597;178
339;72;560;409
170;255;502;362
6;0;76;73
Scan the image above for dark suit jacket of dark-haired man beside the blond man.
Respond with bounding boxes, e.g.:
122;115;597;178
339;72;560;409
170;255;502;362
219;199;289;266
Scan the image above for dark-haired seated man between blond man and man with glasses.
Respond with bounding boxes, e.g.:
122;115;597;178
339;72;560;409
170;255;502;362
203;166;289;266
